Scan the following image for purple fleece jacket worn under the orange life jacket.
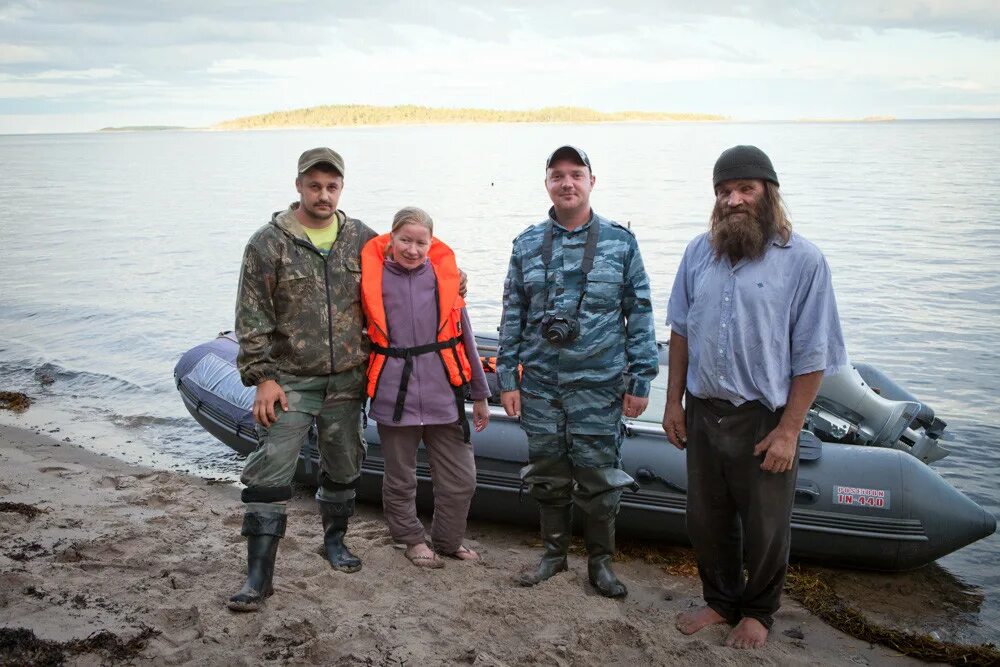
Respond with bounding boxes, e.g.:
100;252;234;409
368;259;490;426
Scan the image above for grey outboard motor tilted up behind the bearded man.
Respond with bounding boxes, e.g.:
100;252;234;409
806;365;950;463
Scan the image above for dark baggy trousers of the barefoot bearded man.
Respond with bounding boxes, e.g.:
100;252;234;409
685;394;798;628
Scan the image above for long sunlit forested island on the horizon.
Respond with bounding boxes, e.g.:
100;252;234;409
215;104;729;130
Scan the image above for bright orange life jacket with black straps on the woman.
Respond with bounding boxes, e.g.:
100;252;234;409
361;234;472;438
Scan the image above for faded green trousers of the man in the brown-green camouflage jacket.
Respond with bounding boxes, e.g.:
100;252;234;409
241;366;366;497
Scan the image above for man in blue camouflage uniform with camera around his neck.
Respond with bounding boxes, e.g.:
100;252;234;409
497;146;659;597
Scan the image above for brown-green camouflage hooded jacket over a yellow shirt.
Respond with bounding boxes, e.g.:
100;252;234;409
236;203;376;387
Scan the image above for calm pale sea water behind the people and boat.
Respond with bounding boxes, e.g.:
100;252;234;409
0;121;1000;641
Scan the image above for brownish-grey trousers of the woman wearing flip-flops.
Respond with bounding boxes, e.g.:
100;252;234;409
378;424;476;554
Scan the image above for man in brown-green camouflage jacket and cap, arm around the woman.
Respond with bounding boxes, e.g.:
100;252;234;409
229;148;376;611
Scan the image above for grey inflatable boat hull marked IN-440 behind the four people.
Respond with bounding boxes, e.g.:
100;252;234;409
175;337;996;570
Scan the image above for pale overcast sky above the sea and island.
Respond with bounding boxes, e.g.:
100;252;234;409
0;0;1000;133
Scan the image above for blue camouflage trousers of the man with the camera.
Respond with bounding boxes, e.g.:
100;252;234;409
521;382;633;513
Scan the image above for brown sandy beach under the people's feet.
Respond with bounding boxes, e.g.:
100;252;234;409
0;426;925;667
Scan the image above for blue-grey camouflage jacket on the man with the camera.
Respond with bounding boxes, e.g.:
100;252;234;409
497;209;659;397
